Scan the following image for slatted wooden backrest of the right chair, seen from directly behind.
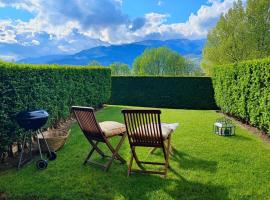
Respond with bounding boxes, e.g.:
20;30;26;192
122;110;163;146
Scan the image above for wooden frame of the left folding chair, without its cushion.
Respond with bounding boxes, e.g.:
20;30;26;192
71;106;127;171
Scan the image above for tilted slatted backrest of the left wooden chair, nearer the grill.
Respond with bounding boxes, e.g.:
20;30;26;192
71;106;104;141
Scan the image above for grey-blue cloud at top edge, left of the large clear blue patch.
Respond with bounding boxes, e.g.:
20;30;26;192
38;0;127;29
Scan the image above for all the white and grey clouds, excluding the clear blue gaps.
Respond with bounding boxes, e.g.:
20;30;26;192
0;0;235;58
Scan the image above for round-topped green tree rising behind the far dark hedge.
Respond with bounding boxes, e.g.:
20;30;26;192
133;47;189;76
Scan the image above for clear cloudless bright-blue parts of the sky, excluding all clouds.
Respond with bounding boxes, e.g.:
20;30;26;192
0;0;208;23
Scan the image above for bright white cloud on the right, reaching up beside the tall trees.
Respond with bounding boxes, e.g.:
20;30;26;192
130;0;235;39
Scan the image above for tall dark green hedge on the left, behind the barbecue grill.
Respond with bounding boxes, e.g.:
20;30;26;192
0;62;111;149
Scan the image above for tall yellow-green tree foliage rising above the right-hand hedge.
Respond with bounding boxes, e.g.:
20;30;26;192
202;0;270;74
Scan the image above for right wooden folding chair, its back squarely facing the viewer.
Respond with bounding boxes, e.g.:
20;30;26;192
122;110;172;177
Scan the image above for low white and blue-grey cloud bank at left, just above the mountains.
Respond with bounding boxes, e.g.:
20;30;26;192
0;25;108;60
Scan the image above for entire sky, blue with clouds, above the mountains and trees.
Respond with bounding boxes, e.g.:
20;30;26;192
0;0;235;60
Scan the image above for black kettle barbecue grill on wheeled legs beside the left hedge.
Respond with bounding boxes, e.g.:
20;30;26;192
16;110;56;169
